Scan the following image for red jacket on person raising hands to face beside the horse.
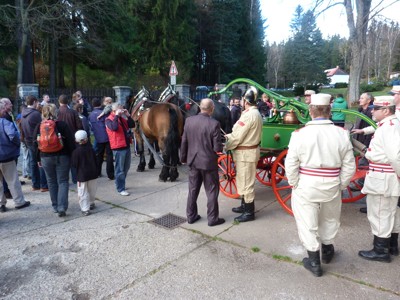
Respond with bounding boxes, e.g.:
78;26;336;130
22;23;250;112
106;112;134;150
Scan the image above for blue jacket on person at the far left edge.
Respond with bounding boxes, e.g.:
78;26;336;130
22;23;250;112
0;118;21;163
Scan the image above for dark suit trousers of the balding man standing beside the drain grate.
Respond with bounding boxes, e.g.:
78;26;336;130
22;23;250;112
186;168;219;224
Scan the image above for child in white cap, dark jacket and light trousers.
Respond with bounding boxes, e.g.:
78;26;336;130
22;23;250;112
71;130;98;216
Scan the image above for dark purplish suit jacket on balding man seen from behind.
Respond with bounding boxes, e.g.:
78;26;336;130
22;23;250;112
181;113;223;170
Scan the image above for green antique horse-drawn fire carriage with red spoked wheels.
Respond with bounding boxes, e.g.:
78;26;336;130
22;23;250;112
209;78;376;214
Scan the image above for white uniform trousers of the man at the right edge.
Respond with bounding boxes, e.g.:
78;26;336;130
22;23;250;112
367;194;400;238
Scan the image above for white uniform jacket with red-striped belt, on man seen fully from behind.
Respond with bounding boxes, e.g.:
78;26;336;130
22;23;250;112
285;120;356;202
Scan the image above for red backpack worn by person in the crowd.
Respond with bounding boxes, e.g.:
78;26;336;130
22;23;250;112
37;120;64;153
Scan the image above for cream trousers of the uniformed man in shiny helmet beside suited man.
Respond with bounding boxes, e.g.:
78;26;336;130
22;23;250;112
233;156;257;203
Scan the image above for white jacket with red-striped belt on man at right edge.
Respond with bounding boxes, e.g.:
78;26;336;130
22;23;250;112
362;115;400;197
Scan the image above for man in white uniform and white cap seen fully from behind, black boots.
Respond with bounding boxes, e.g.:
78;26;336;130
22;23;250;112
285;94;355;277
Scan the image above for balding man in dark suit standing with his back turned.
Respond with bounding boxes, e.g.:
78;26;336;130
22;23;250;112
181;98;225;226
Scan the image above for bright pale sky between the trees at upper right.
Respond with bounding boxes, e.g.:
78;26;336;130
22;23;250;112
260;0;400;44
